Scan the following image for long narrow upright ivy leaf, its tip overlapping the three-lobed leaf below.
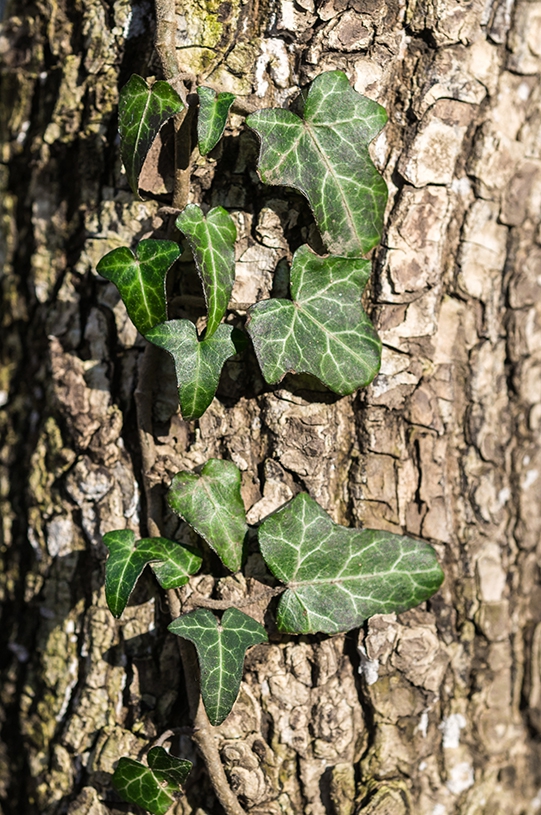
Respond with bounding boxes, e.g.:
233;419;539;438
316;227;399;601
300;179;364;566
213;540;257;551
176;210;237;339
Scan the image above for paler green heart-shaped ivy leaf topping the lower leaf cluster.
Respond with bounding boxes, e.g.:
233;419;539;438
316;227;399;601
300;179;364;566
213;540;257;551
167;458;248;572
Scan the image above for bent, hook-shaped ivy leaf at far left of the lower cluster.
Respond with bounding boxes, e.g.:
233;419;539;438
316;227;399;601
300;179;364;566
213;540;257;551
103;529;201;617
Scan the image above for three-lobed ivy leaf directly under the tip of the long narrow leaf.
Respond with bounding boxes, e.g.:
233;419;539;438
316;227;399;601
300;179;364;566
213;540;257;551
145;320;237;420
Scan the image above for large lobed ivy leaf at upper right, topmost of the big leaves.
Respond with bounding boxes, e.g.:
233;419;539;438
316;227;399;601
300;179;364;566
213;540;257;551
246;71;387;257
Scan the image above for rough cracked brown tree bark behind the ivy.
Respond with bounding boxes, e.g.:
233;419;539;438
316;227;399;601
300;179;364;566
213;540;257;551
0;0;541;815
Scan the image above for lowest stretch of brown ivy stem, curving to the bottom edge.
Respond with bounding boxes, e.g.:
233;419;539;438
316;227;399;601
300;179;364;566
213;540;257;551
167;589;246;815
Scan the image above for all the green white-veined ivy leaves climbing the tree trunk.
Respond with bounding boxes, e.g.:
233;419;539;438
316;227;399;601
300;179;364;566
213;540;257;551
97;71;443;815
